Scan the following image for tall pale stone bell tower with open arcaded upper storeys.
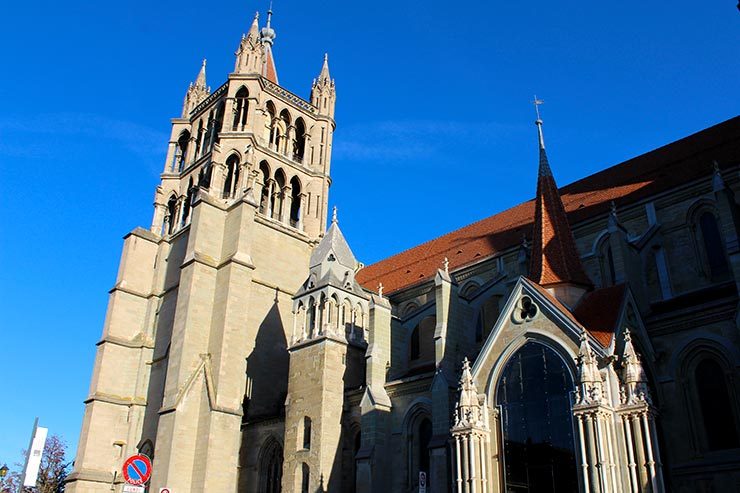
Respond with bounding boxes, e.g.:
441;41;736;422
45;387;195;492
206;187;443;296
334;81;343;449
68;12;338;493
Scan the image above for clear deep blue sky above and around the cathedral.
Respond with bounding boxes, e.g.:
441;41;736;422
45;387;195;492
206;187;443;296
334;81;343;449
0;0;740;463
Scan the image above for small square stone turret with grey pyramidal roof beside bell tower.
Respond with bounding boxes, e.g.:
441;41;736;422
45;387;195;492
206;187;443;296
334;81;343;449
282;210;369;493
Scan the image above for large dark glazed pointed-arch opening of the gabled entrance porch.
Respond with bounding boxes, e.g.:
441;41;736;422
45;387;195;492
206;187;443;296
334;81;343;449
496;342;578;493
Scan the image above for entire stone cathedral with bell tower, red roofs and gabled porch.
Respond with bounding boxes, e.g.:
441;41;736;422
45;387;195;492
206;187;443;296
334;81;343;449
67;7;740;493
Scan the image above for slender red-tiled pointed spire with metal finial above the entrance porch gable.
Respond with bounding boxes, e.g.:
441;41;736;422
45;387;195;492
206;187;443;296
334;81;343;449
529;97;592;308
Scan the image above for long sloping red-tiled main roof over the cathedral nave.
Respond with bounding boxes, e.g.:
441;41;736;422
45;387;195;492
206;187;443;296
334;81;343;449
357;117;740;293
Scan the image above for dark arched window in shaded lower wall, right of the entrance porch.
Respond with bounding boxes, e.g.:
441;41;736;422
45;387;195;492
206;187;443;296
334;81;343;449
695;358;740;450
